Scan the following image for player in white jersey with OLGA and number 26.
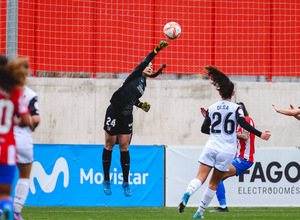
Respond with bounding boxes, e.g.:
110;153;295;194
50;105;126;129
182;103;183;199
178;66;271;218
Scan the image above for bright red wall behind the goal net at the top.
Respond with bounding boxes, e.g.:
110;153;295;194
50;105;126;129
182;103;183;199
0;0;300;78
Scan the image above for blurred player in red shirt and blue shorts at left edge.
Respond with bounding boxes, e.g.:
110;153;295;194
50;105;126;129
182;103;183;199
0;55;30;220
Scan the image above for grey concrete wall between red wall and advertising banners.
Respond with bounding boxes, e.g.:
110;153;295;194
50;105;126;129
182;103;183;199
28;78;300;146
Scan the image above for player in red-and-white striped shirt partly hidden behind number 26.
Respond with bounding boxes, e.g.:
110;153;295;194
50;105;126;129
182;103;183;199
210;102;255;212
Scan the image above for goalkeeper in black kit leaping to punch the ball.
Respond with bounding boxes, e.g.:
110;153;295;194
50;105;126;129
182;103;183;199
102;41;169;196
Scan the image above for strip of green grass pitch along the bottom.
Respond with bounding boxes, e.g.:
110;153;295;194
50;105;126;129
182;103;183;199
22;207;300;220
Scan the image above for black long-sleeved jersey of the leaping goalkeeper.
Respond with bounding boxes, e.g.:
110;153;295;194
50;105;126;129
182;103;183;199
110;51;156;115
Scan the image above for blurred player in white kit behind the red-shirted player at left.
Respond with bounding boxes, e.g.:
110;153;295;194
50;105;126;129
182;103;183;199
14;86;40;220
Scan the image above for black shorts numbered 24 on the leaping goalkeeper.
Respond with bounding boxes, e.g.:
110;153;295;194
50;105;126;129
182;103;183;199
103;105;133;135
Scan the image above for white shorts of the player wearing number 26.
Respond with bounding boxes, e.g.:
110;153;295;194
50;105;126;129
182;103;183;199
198;147;234;172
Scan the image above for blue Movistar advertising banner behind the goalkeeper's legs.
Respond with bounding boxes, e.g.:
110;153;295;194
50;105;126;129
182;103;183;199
26;144;164;206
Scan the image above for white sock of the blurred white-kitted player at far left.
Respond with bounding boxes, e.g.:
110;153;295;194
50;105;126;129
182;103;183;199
14;178;30;213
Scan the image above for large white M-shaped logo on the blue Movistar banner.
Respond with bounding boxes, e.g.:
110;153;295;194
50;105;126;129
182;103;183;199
30;157;69;194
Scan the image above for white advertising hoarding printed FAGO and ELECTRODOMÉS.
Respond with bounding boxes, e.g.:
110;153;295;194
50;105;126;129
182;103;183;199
166;146;300;206
